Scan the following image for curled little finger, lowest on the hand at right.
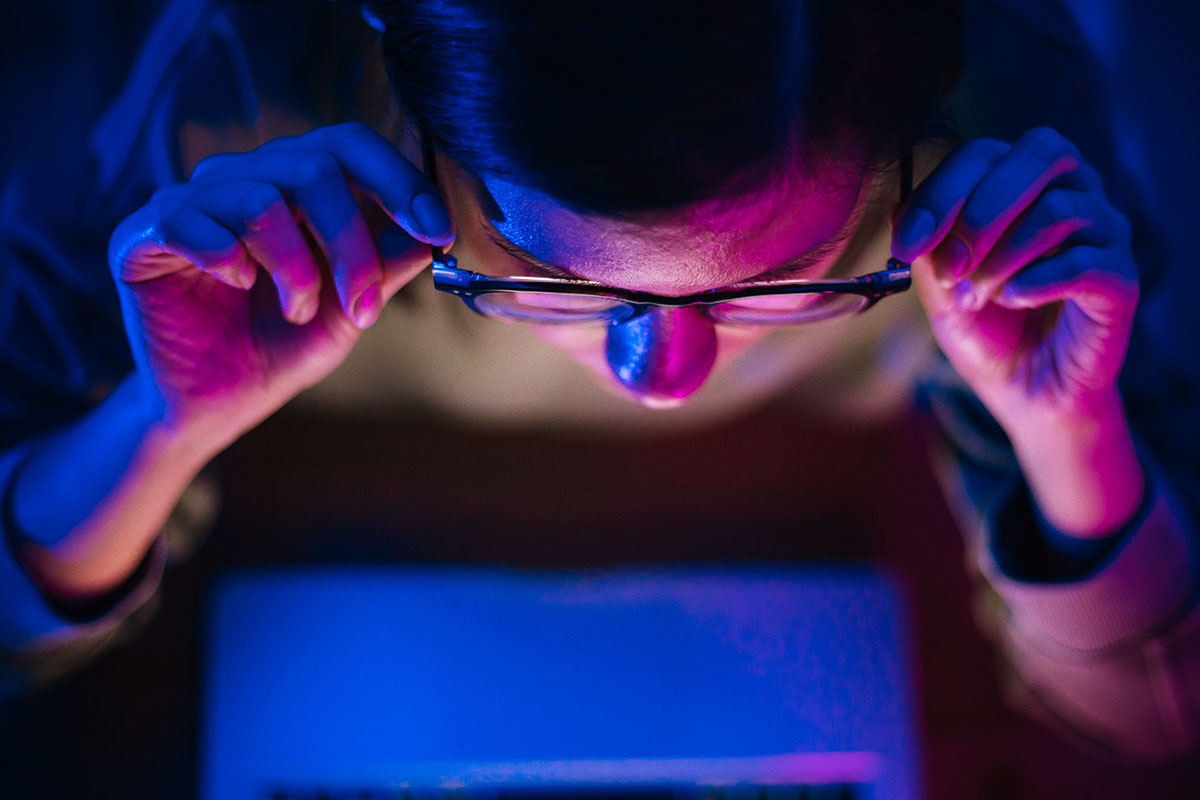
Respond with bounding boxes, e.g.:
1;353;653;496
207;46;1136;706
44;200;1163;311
996;246;1138;325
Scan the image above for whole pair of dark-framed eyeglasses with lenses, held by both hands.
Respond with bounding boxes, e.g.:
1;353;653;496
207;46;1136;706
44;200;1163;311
421;137;912;325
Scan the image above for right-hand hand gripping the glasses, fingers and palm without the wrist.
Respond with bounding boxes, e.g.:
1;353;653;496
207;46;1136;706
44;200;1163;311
893;128;1138;428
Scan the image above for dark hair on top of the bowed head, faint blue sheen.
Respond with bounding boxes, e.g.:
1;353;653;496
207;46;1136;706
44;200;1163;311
370;0;961;215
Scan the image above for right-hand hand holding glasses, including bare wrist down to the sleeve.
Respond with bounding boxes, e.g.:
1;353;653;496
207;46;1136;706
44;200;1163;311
892;128;1145;536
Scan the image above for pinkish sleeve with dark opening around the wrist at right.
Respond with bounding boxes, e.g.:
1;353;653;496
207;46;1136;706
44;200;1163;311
974;455;1200;759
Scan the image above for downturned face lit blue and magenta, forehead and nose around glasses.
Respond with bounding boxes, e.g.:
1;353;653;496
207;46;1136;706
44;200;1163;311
439;158;866;408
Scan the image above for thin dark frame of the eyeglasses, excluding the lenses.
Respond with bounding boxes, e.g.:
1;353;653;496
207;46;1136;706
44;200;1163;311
420;134;912;327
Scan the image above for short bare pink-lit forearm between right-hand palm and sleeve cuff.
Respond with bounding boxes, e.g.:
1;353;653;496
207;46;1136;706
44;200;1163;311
1004;389;1146;539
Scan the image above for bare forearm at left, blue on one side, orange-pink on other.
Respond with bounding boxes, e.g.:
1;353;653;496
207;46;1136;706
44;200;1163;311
8;377;215;600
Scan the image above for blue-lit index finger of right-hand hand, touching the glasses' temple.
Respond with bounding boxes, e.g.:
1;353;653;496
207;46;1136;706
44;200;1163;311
892;139;1009;263
